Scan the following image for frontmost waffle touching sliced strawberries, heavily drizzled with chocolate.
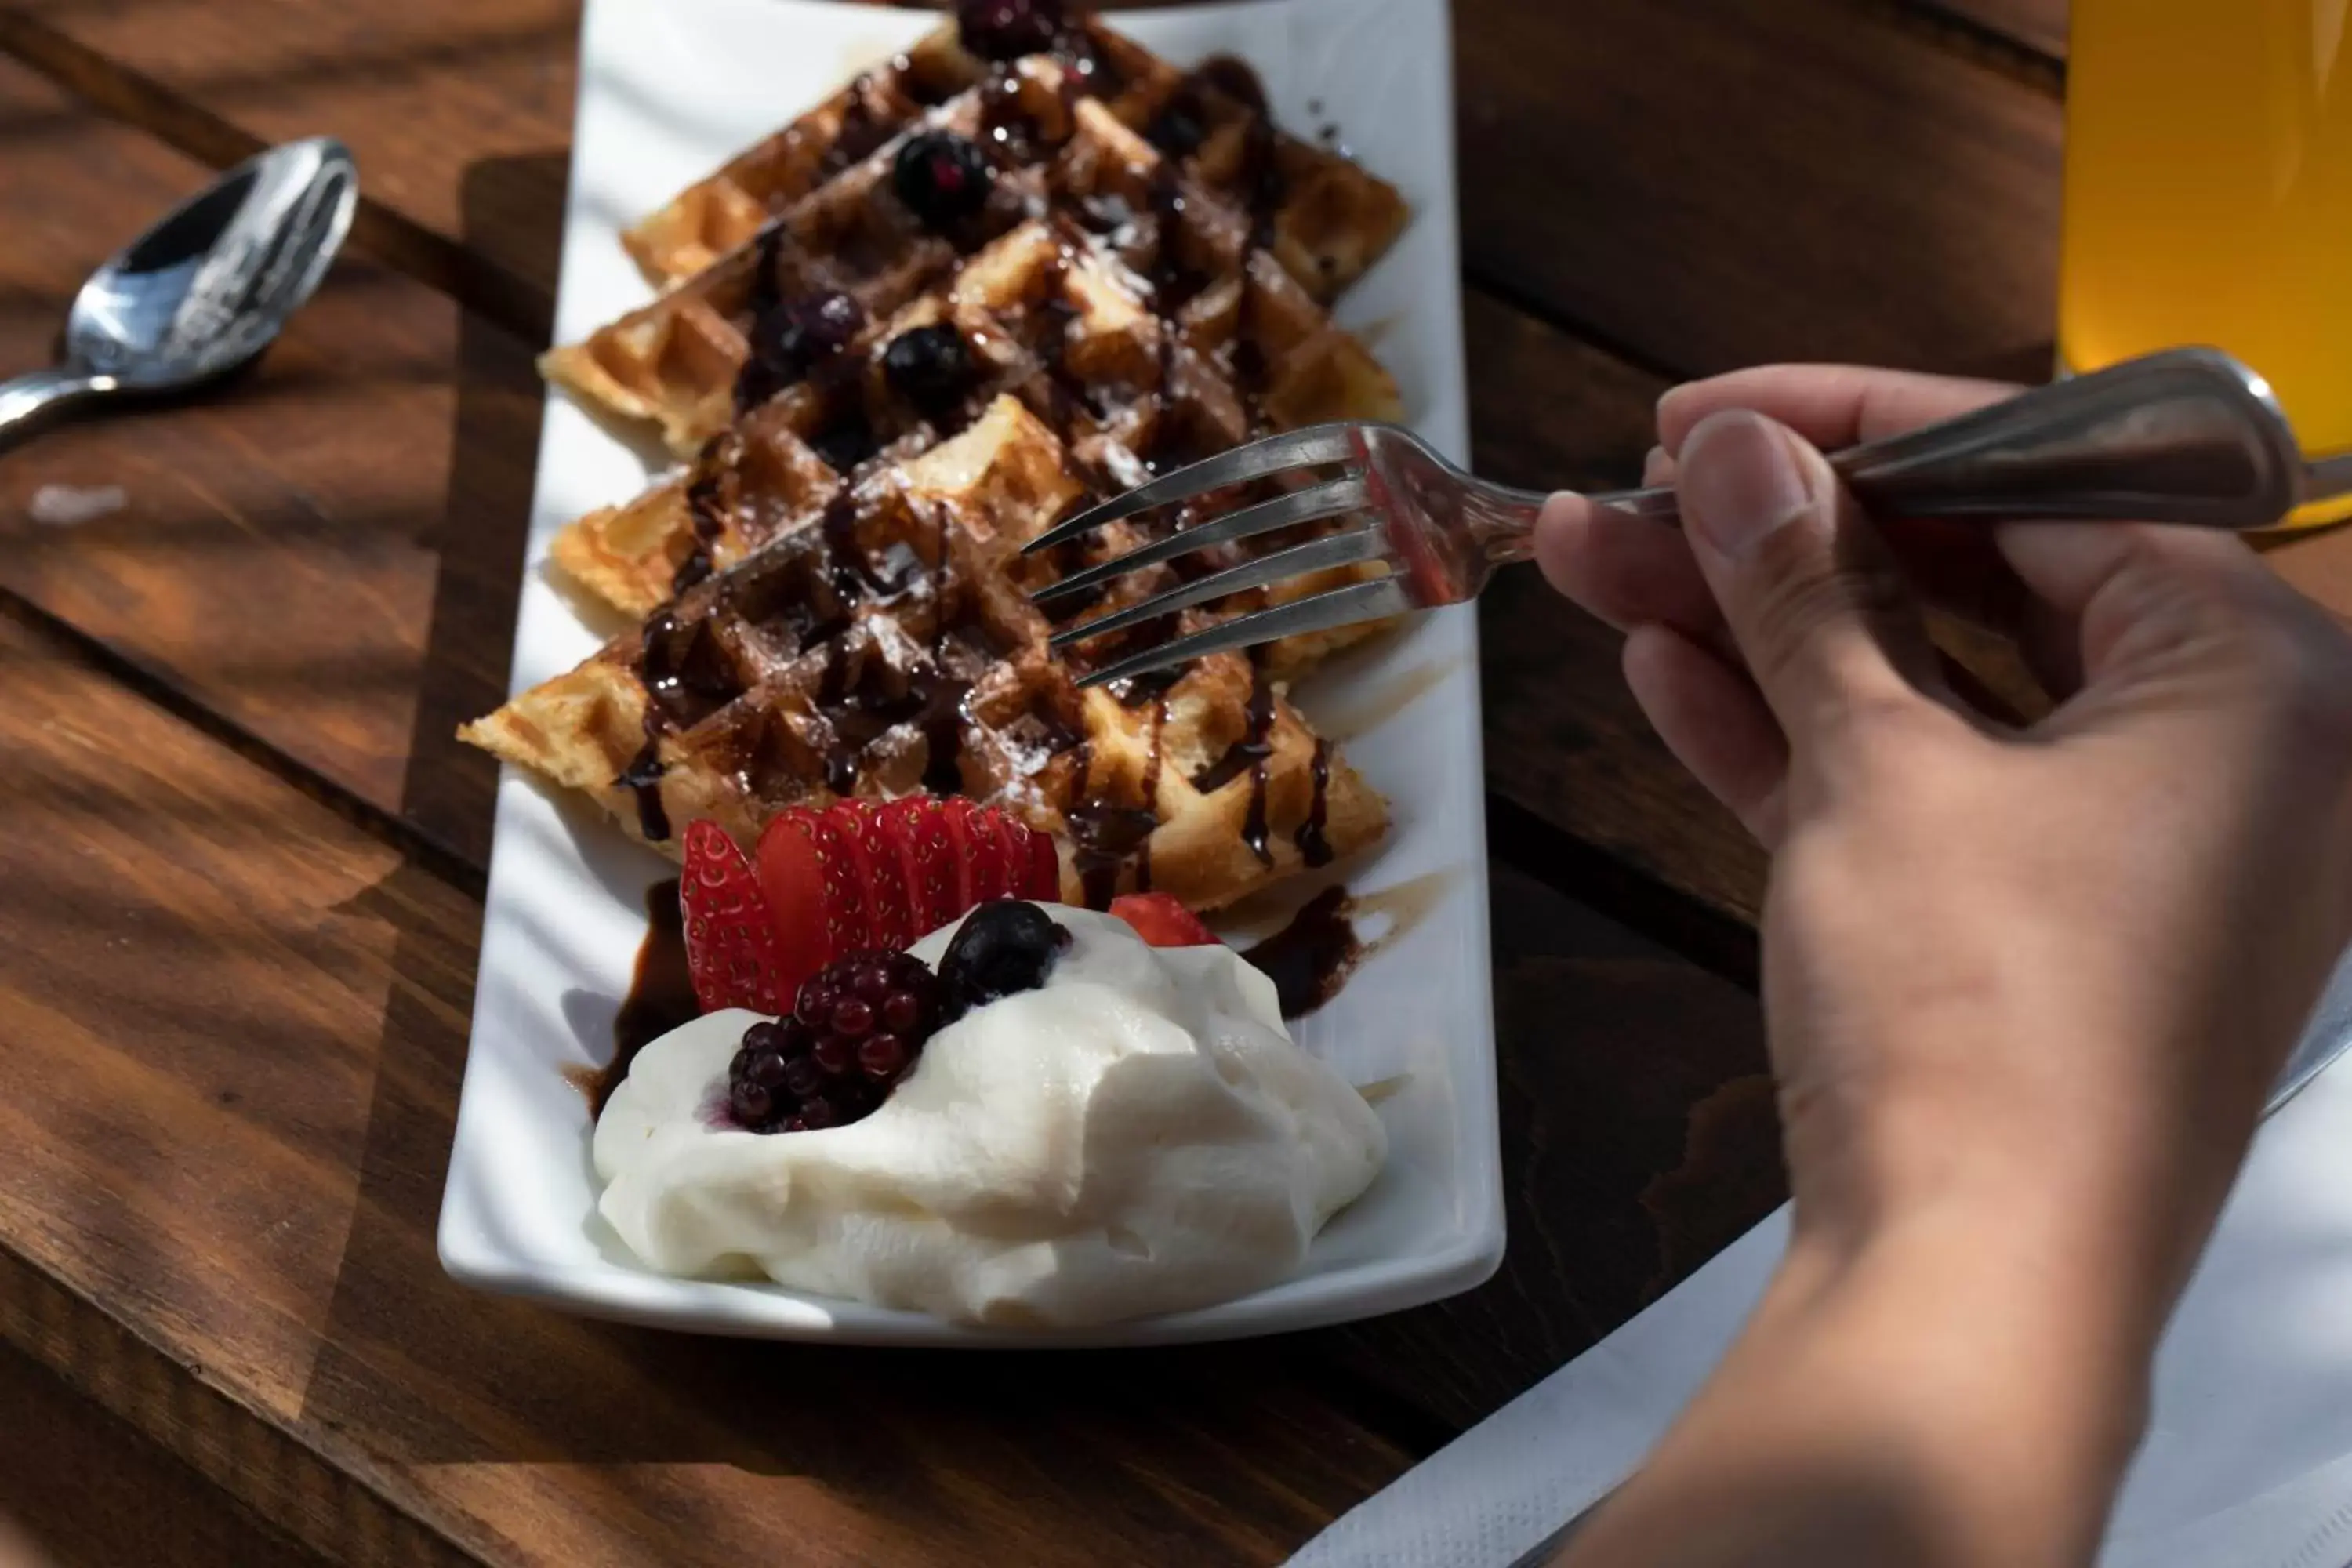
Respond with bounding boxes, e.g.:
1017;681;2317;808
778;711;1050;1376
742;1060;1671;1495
461;395;1388;909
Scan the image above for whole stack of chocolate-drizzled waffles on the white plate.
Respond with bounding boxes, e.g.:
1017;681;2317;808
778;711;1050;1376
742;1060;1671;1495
461;5;1406;909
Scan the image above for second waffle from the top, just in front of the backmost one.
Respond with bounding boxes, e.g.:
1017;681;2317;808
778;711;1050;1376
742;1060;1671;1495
541;44;1404;456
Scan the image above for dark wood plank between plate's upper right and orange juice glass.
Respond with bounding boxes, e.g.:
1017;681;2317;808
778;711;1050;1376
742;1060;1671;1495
1456;0;2060;374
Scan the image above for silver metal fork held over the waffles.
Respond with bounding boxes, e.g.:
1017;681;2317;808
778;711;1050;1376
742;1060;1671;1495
1023;348;2352;687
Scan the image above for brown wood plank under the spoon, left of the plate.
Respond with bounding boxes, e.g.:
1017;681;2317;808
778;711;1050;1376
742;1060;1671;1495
0;59;539;862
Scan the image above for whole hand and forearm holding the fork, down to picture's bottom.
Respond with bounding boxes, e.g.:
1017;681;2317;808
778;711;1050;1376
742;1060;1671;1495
1536;367;2352;1561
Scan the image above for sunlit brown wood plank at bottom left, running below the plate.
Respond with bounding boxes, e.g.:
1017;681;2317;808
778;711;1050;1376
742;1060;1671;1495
0;621;1409;1566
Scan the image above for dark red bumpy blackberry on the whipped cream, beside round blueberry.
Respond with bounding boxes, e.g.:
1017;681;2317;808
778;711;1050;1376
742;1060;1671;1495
727;949;946;1133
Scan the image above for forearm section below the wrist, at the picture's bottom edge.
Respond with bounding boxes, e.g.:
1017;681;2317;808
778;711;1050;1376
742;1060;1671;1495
1569;1203;2152;1568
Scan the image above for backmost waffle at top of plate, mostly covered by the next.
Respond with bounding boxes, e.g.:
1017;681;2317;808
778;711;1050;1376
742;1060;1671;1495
621;19;1406;303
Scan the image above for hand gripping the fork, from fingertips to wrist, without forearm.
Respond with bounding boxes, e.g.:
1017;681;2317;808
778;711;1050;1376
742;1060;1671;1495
1538;367;2352;1281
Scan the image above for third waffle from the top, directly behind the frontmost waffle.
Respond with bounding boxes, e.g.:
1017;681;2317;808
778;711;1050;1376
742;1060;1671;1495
553;161;1402;644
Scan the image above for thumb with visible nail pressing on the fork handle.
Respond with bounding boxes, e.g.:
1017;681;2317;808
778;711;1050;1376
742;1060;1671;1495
1677;409;1943;750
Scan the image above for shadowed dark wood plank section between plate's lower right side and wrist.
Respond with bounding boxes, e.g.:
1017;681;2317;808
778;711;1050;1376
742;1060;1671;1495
1343;867;1785;1425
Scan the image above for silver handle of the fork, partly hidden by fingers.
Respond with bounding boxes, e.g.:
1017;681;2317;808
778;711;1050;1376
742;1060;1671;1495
1595;348;2305;529
